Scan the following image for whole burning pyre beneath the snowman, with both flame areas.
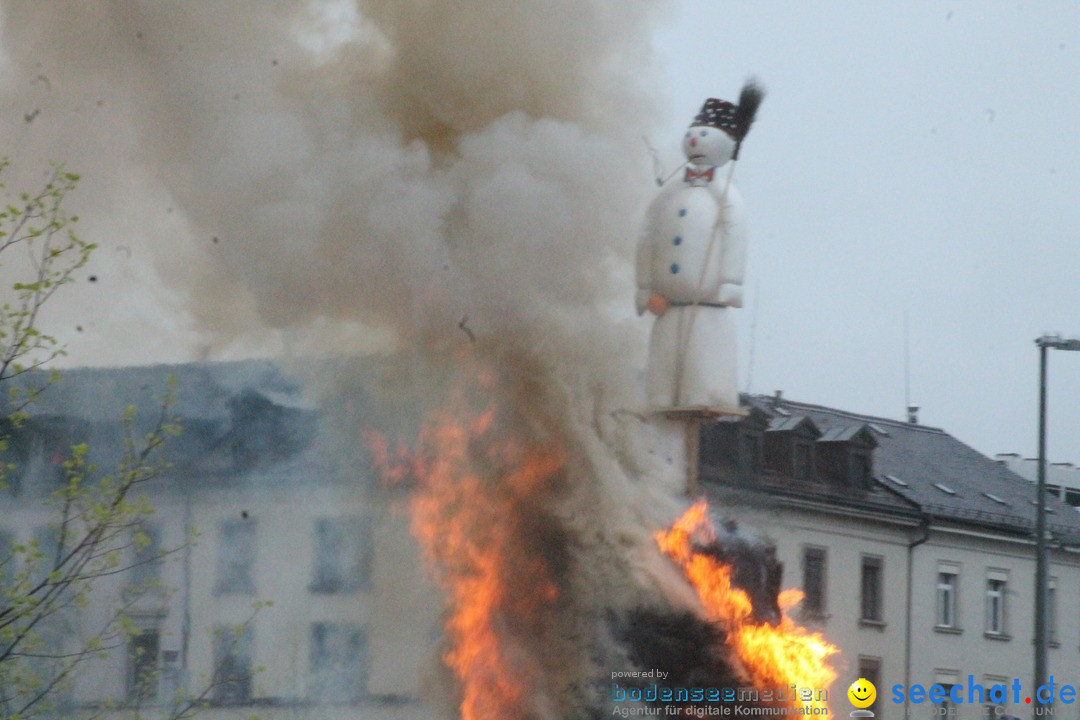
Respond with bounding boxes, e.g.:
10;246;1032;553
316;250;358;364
367;356;836;720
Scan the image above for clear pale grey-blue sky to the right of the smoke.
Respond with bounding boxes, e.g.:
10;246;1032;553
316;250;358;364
651;0;1080;463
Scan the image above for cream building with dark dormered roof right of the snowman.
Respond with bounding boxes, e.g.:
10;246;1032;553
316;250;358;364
701;396;1080;718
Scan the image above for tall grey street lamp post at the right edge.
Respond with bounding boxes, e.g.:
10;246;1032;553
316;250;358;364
1035;335;1080;705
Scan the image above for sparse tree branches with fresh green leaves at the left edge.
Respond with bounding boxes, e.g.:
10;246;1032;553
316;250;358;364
0;160;178;720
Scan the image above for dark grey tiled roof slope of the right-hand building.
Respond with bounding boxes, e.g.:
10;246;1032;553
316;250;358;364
742;395;1080;544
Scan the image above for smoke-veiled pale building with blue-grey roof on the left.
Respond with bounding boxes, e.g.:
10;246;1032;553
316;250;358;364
0;362;441;720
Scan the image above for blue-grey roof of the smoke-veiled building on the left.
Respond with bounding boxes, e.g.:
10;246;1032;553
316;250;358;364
3;361;345;499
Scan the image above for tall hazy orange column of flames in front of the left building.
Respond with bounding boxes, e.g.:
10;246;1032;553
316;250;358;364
366;373;564;720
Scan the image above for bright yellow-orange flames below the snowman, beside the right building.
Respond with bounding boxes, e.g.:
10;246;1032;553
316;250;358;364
654;501;837;707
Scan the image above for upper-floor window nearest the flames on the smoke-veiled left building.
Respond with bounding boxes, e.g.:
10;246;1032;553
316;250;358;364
310;516;372;593
